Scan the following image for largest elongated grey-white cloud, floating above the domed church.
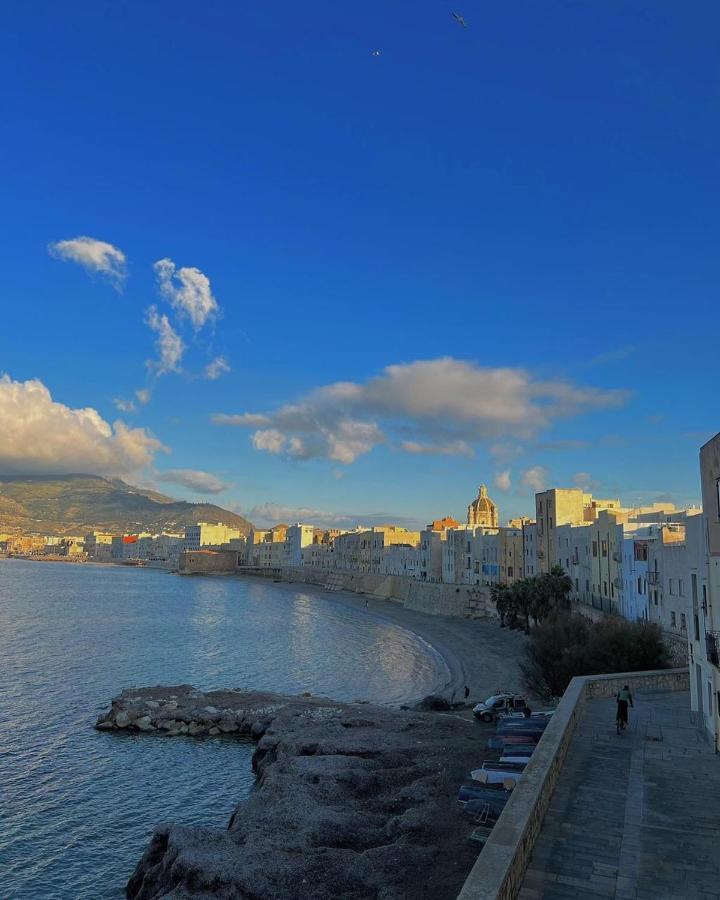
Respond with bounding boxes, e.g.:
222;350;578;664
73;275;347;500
213;357;628;463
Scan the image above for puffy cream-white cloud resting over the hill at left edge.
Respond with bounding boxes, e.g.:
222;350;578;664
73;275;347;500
0;375;165;475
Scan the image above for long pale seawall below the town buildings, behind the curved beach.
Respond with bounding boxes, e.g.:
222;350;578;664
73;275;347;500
237;566;496;619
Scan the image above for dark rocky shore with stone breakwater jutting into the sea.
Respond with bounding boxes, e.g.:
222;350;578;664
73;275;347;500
96;685;487;900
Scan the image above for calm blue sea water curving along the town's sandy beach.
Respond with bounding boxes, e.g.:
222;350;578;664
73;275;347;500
0;560;448;900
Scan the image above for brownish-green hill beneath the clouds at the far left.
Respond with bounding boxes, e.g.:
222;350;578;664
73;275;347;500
0;475;252;535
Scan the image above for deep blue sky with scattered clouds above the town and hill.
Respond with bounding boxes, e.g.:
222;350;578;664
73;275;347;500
0;0;720;523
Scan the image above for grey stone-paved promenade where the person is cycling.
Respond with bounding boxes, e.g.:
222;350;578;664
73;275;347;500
519;684;720;900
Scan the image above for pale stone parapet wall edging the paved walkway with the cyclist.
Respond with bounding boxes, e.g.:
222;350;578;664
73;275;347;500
458;668;690;900
